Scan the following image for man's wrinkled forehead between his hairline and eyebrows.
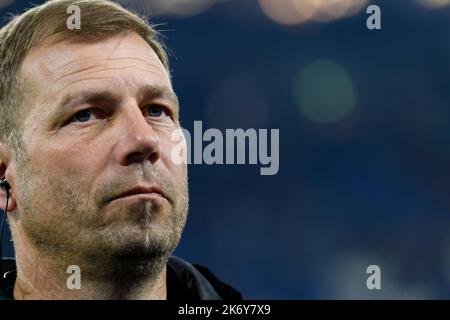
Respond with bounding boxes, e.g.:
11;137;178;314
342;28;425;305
22;33;171;99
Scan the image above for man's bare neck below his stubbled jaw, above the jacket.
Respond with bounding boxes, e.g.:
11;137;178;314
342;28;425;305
14;230;167;300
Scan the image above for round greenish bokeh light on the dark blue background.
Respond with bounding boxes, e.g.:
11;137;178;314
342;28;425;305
294;60;355;123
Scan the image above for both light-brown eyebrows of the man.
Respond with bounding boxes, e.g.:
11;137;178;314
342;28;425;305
56;85;179;116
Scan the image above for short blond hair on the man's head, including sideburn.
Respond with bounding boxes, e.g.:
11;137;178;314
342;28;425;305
0;0;170;156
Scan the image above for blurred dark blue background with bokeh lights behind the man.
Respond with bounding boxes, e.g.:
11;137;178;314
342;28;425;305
0;0;450;299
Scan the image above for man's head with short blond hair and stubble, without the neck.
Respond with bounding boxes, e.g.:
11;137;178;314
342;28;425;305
0;0;188;280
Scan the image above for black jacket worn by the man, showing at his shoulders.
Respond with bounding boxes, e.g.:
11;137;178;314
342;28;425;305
0;256;243;301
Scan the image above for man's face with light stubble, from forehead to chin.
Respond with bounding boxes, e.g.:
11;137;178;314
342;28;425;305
15;33;188;263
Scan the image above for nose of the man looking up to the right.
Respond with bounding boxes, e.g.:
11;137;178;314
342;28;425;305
115;104;160;166
